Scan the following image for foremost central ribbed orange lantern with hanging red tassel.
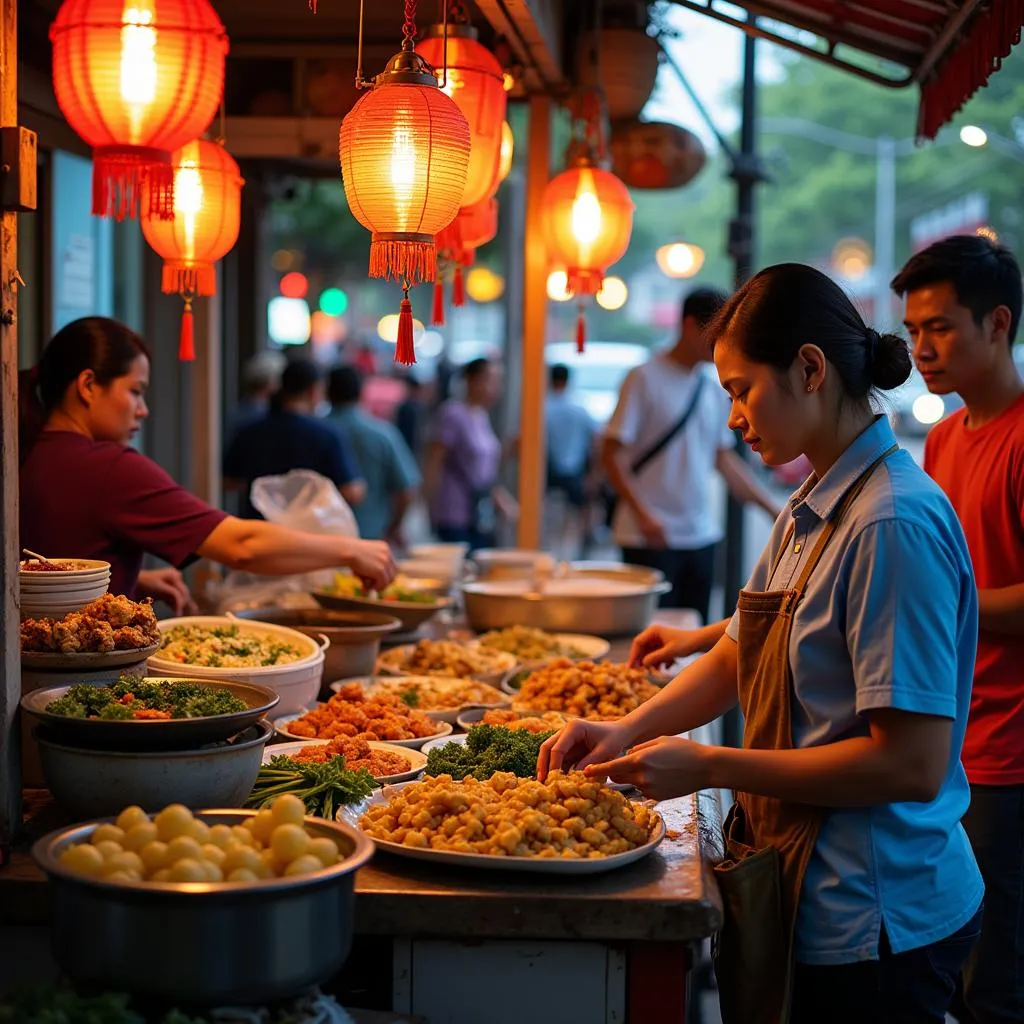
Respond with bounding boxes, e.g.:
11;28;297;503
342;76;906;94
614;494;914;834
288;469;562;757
339;0;470;365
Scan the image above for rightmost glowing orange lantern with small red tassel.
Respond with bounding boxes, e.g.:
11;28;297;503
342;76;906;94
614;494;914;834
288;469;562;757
543;157;634;351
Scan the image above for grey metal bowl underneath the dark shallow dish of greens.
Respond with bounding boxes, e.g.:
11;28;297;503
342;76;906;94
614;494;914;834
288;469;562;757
35;719;273;819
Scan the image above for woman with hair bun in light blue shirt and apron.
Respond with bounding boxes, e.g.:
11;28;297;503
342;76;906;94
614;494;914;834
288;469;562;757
538;263;983;1024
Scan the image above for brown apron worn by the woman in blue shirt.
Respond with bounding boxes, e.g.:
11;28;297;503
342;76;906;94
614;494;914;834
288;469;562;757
713;445;897;1024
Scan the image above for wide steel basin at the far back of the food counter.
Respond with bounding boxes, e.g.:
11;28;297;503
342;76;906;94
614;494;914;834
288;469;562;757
463;562;672;637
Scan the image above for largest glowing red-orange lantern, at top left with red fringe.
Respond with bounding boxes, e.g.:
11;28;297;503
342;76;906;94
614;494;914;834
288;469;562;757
50;0;227;220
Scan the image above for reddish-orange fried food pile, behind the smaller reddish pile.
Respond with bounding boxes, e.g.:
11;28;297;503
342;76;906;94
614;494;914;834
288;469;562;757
288;683;440;740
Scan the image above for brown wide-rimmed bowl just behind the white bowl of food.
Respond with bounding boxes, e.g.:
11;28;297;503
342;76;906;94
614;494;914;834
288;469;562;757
228;608;401;681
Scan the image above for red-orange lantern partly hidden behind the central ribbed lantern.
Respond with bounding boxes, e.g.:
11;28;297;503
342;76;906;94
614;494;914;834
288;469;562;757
416;25;508;207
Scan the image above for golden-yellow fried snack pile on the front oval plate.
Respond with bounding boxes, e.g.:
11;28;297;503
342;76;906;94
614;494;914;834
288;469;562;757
359;771;657;860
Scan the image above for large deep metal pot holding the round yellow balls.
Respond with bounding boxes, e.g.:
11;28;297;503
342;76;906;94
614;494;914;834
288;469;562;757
32;802;374;1006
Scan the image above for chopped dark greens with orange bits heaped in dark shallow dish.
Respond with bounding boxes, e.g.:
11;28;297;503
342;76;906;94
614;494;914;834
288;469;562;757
46;676;249;720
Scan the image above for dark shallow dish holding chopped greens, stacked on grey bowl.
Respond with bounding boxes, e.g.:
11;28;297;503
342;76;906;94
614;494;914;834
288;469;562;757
22;676;281;751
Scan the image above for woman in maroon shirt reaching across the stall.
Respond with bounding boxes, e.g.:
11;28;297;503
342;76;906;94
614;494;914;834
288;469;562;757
20;316;395;614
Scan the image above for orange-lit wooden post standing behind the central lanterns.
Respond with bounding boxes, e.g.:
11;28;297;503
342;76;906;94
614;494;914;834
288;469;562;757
519;95;551;549
